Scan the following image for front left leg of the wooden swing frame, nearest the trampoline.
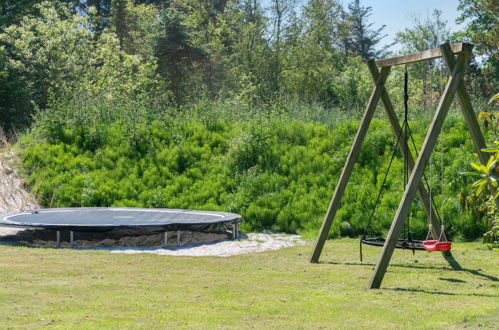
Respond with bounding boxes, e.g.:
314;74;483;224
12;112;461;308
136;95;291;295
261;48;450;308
310;67;390;262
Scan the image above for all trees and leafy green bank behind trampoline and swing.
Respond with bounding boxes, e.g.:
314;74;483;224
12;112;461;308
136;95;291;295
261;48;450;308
0;0;496;244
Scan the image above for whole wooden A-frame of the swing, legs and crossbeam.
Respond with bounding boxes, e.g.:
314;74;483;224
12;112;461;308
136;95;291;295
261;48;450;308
310;43;498;289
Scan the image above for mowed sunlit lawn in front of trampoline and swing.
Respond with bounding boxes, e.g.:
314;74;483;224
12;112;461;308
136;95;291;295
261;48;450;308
0;239;499;329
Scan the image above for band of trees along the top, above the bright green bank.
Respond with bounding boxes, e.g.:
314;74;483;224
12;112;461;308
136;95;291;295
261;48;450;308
0;0;498;128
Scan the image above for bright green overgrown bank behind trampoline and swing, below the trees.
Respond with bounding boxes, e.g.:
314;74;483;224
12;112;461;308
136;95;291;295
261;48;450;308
20;101;486;240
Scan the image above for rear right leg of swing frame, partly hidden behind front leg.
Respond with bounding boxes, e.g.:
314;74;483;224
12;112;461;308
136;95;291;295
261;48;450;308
437;43;499;210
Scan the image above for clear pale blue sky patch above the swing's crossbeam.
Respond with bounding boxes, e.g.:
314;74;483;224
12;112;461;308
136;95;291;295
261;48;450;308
343;0;460;51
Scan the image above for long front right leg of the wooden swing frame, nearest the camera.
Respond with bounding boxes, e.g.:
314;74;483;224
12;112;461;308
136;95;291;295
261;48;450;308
369;53;470;289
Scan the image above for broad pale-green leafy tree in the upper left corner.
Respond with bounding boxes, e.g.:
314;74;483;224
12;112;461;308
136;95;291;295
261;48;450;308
0;1;162;127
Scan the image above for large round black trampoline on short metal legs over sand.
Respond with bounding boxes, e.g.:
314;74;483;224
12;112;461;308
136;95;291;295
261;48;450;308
0;207;242;247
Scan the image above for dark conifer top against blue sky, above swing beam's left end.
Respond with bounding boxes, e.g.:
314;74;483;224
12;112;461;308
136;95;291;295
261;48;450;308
346;0;391;60
